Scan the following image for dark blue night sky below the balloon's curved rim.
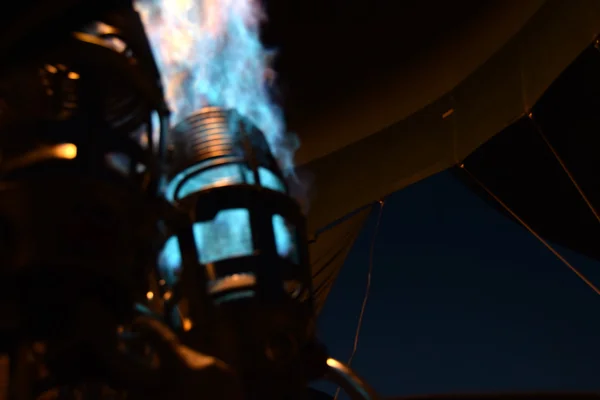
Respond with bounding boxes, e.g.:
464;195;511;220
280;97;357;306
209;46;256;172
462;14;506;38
320;172;600;395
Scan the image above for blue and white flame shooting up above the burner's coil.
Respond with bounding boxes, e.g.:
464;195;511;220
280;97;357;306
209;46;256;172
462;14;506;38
136;0;298;176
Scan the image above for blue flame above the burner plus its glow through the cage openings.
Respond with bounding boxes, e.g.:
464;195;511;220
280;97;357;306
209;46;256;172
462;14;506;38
136;0;298;280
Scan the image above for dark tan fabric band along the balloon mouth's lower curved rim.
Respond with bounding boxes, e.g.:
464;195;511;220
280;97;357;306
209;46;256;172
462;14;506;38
301;0;600;231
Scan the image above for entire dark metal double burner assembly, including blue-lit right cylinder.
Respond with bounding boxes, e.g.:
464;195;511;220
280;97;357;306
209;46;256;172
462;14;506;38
0;0;382;399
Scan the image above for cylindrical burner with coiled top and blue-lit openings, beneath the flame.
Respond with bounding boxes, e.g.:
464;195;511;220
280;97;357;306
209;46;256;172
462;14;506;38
162;107;314;396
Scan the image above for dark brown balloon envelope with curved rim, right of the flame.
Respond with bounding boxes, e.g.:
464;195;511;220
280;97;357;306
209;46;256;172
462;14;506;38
265;0;600;307
